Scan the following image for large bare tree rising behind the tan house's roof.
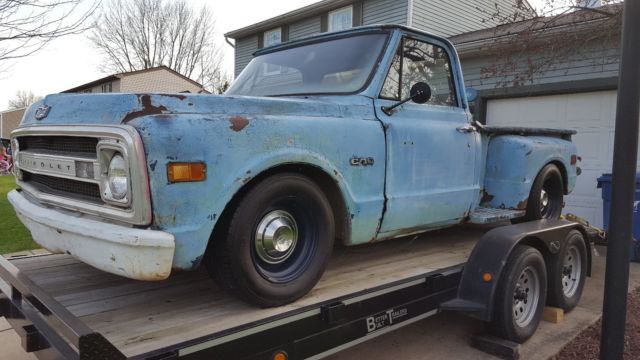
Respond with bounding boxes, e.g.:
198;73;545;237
90;0;228;90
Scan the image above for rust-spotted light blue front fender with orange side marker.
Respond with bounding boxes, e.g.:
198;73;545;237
130;110;385;269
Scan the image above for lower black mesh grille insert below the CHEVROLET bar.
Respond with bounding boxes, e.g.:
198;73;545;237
22;171;102;203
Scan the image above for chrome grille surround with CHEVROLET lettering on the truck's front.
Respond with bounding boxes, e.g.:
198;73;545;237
11;125;151;225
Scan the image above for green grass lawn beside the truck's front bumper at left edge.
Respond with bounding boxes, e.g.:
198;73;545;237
0;176;40;254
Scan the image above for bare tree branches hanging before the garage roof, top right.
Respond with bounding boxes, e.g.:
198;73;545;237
477;0;622;87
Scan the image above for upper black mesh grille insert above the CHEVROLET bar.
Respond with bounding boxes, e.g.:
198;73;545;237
18;136;98;158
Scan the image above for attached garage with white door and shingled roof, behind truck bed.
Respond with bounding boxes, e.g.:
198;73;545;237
450;4;621;226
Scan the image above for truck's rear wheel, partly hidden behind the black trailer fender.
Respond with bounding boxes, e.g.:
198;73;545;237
522;164;564;221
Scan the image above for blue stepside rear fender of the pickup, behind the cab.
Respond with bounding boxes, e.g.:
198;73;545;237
482;135;576;210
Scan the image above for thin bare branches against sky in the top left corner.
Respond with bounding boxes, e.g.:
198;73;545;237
0;0;97;62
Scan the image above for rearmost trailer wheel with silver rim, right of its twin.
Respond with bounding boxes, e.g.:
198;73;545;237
547;230;587;312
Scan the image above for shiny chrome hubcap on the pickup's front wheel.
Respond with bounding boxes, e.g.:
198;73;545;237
255;210;298;264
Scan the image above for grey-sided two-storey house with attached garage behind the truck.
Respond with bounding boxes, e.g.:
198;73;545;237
225;0;621;226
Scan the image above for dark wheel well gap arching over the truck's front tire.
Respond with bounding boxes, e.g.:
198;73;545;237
207;164;350;252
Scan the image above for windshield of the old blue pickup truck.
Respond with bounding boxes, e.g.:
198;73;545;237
227;33;387;96
